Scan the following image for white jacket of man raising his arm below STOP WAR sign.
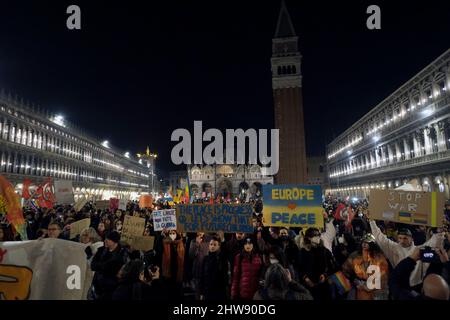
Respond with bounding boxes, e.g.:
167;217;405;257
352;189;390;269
370;220;444;286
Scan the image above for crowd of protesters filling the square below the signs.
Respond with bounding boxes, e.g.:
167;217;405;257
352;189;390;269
0;197;450;301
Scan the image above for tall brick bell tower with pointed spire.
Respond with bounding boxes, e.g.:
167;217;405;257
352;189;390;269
271;1;307;184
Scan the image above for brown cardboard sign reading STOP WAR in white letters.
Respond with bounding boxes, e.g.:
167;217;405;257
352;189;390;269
369;189;445;227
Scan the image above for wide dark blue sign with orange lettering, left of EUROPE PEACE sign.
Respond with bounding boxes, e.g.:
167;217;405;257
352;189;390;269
177;203;254;233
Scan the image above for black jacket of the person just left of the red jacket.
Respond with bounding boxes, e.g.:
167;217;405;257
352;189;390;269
199;252;228;301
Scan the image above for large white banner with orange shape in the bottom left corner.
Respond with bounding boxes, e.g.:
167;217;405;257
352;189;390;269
0;238;93;300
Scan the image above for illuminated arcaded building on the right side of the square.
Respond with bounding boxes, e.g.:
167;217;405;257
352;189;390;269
326;49;450;198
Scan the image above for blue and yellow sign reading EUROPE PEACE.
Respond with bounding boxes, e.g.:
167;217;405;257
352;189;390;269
263;184;324;228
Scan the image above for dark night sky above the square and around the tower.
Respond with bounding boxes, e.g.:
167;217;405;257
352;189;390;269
0;0;450;176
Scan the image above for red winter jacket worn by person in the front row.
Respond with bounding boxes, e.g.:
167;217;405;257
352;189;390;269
231;253;263;300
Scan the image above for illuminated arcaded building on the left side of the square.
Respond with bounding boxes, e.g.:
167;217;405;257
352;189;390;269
0;92;153;199
